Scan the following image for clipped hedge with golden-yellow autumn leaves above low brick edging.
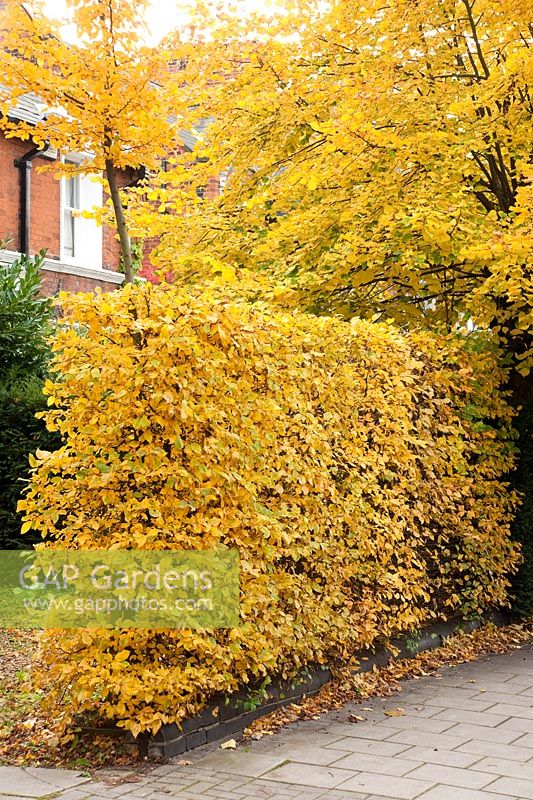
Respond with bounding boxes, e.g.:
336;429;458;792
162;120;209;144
21;285;519;734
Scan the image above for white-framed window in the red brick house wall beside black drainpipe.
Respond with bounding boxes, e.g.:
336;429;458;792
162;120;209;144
61;157;102;269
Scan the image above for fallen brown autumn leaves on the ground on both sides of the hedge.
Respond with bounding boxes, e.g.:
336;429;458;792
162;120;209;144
0;621;533;769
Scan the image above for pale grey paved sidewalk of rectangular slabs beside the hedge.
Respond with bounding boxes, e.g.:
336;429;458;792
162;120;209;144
0;645;533;800
